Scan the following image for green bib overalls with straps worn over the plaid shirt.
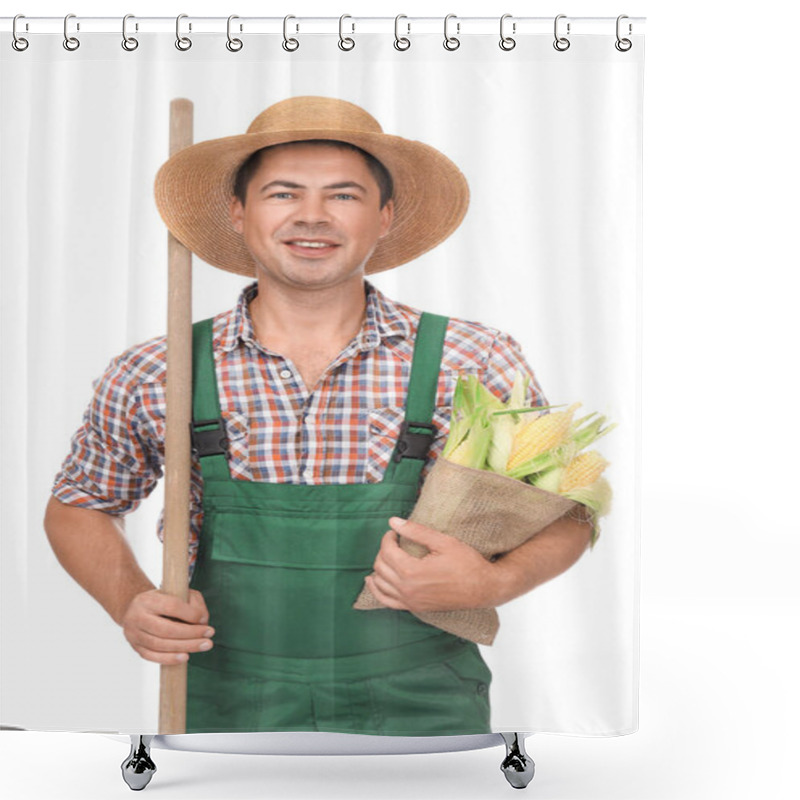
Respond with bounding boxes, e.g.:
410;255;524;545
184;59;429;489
187;314;491;736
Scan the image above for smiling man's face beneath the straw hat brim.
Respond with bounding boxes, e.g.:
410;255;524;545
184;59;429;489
231;144;393;288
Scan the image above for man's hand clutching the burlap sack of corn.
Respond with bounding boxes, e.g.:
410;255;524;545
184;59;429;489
366;517;496;612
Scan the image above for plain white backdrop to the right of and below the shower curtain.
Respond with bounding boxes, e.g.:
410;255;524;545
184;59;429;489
0;0;800;800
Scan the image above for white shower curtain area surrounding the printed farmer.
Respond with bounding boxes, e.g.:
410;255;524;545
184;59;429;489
0;19;644;736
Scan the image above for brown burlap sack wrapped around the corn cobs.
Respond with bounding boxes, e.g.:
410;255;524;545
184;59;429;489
353;458;584;644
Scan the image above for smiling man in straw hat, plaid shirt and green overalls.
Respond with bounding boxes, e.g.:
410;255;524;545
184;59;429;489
45;97;591;735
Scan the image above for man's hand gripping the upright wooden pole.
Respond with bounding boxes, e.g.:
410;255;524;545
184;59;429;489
120;589;214;664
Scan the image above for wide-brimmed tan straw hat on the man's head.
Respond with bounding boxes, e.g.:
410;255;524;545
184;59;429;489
155;97;469;275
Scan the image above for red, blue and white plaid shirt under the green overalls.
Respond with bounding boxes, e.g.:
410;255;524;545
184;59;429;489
53;281;546;564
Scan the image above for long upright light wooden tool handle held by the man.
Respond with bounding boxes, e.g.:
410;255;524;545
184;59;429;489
158;99;193;734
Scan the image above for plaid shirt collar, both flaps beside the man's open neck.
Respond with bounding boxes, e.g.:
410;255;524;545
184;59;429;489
219;280;411;351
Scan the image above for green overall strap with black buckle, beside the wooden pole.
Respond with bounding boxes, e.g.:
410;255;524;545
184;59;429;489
192;318;230;481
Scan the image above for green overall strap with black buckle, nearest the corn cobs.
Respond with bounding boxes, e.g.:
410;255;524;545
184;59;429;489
383;312;449;486
